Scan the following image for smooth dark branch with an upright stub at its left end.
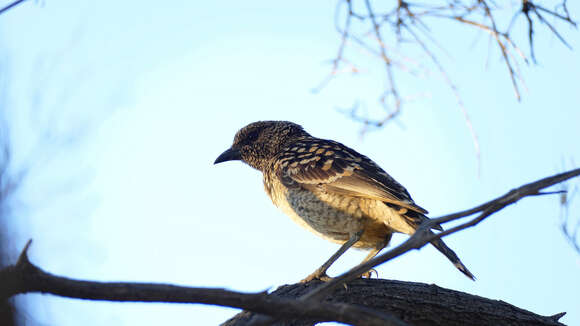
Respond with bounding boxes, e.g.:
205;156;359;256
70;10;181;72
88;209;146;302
0;242;407;326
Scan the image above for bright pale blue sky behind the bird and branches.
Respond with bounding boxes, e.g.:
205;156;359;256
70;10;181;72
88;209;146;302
0;0;580;326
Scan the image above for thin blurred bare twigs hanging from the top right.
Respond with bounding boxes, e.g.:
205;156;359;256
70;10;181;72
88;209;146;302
324;0;576;154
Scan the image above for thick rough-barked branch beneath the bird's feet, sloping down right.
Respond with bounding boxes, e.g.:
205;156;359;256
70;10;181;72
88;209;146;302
222;279;562;326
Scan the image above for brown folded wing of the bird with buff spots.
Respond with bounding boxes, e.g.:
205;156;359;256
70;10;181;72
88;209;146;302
277;139;427;216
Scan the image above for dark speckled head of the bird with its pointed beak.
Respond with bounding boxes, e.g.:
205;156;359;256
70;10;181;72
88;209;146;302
214;121;308;171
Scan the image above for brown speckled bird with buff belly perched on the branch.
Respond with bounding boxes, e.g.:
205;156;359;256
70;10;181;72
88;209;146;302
214;121;475;282
